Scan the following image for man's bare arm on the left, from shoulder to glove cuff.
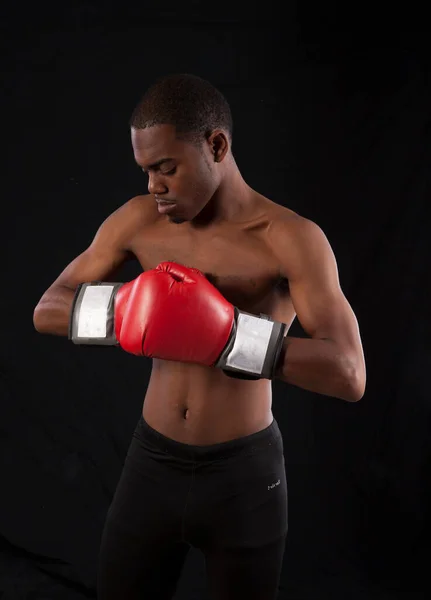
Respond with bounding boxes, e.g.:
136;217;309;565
33;198;147;336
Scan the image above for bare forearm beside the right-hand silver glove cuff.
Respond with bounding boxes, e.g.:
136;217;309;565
276;336;363;402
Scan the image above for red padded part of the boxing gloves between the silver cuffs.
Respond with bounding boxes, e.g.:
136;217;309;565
115;262;234;366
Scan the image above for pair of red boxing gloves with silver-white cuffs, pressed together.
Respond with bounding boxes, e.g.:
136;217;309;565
69;262;286;379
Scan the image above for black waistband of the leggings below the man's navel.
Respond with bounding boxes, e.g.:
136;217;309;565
135;416;282;461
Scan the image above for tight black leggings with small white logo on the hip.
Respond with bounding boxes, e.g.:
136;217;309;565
97;418;287;600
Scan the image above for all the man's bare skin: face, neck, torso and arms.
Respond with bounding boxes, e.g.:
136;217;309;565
34;125;366;445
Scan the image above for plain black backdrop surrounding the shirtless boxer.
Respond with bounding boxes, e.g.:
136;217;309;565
0;1;431;600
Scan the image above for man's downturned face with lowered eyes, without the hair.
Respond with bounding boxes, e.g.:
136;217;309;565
131;125;219;223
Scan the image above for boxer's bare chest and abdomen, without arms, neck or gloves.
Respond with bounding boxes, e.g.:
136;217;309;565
125;197;295;445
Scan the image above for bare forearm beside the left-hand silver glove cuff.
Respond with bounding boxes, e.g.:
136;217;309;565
33;286;75;336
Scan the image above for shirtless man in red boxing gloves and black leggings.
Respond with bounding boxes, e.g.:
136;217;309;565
34;75;366;600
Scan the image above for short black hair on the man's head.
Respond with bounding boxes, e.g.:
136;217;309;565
129;73;233;144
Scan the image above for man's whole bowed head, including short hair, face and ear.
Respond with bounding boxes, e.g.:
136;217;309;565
130;74;232;222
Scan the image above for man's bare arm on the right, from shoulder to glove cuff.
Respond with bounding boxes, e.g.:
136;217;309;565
273;217;366;402
